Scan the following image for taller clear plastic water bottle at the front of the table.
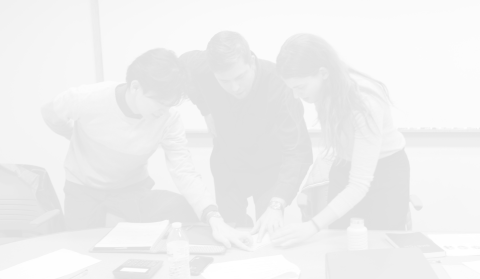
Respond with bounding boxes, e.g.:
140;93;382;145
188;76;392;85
167;223;190;279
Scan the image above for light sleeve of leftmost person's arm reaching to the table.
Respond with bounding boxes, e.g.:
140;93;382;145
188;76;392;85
161;110;215;218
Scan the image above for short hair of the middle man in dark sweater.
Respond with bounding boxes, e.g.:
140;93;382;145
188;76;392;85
207;31;252;72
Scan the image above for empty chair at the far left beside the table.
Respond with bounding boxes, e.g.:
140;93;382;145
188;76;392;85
0;164;65;244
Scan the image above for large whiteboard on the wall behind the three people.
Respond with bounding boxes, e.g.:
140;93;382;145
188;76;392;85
99;0;480;130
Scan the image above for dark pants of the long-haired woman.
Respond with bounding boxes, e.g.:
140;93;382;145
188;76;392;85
328;150;410;230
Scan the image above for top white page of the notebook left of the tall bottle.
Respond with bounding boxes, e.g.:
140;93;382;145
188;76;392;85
95;220;169;248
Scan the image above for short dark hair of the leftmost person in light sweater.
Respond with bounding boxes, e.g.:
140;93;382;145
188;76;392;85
126;48;186;104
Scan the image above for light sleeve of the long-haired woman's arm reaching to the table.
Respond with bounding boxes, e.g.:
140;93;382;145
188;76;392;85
327;100;385;218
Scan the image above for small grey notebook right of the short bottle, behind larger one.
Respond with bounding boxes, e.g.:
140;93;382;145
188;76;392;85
385;232;446;258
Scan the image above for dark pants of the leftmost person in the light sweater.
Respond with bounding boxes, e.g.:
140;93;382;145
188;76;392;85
64;181;198;230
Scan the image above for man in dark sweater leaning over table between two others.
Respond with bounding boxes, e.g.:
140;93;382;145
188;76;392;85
180;31;313;240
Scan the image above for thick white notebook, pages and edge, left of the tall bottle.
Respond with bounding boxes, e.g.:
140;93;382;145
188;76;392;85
91;220;170;253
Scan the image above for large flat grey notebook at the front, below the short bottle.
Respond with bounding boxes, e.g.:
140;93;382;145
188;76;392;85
325;248;438;279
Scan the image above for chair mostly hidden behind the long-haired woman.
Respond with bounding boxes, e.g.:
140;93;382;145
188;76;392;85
297;181;423;230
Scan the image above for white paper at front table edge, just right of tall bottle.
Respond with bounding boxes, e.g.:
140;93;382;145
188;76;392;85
202;255;300;279
